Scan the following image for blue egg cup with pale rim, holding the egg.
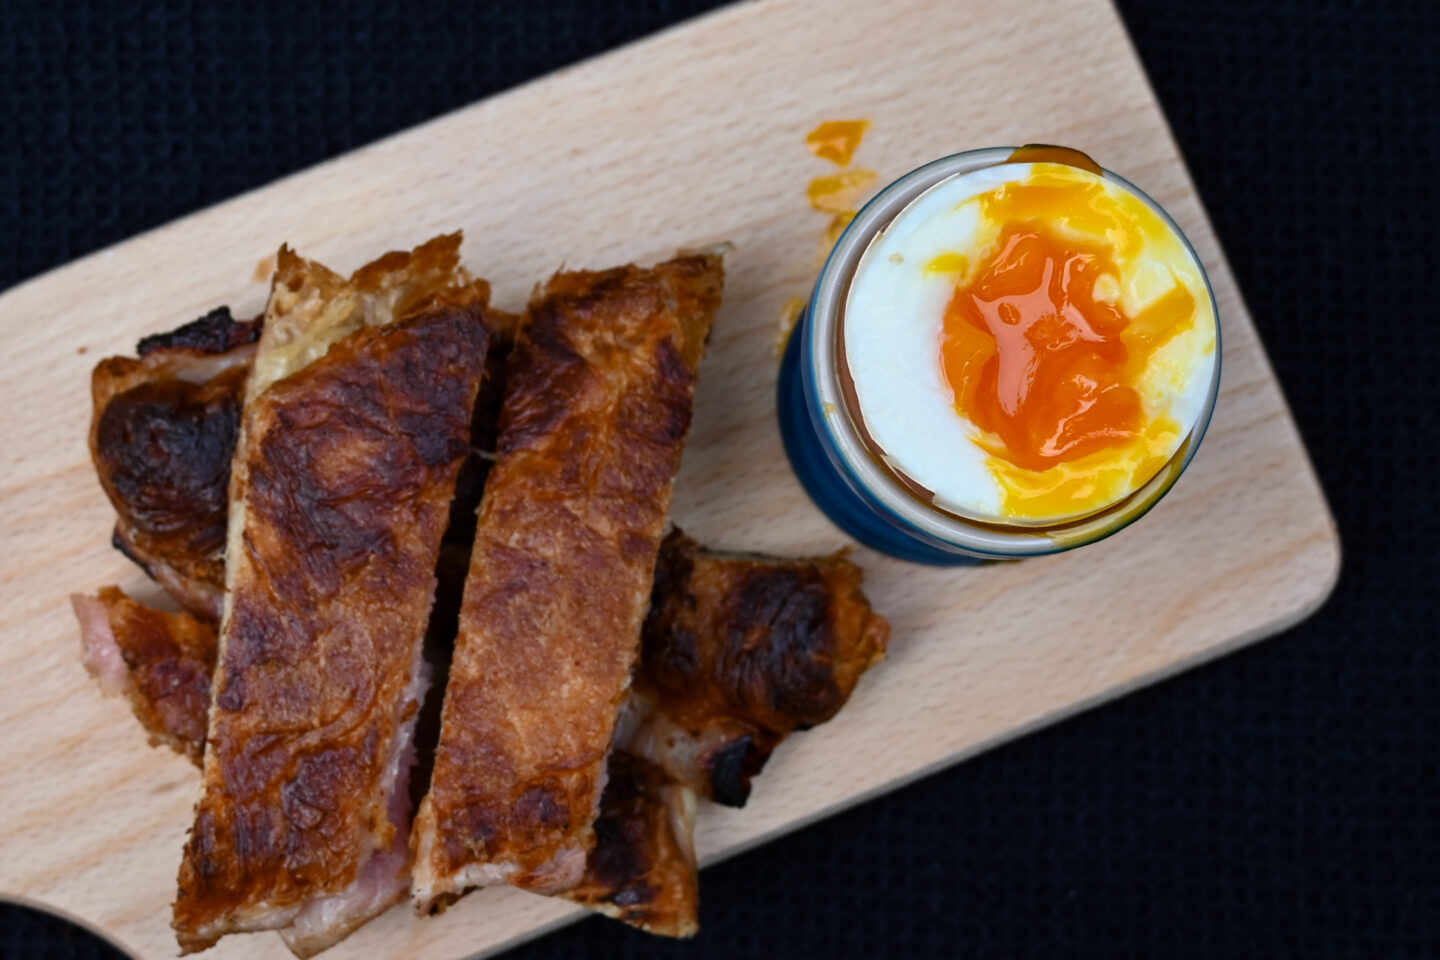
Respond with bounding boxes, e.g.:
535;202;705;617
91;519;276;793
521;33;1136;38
779;147;1221;566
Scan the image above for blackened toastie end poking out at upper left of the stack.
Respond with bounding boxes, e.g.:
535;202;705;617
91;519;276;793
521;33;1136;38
89;307;259;619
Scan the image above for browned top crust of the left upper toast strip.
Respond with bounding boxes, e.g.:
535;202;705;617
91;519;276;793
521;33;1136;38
174;304;487;951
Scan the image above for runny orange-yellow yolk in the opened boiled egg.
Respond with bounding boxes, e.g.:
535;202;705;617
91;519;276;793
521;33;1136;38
927;169;1195;518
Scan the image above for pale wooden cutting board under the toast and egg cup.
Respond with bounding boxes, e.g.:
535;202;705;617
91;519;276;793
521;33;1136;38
0;0;1339;960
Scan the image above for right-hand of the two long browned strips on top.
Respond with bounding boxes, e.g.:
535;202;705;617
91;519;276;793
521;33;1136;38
415;256;723;910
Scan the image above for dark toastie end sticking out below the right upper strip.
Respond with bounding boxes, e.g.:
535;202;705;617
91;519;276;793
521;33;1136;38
564;750;700;937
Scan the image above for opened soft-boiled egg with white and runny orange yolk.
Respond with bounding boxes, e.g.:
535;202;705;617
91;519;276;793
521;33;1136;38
841;163;1215;525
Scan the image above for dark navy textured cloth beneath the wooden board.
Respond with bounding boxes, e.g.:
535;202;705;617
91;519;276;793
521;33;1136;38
0;0;1440;960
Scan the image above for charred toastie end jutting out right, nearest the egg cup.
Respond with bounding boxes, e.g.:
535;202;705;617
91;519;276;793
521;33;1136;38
632;530;890;806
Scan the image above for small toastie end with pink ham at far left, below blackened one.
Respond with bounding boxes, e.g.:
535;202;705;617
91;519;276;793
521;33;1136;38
75;587;216;766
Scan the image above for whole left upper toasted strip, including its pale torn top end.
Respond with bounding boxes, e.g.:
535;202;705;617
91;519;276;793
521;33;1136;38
174;235;488;956
